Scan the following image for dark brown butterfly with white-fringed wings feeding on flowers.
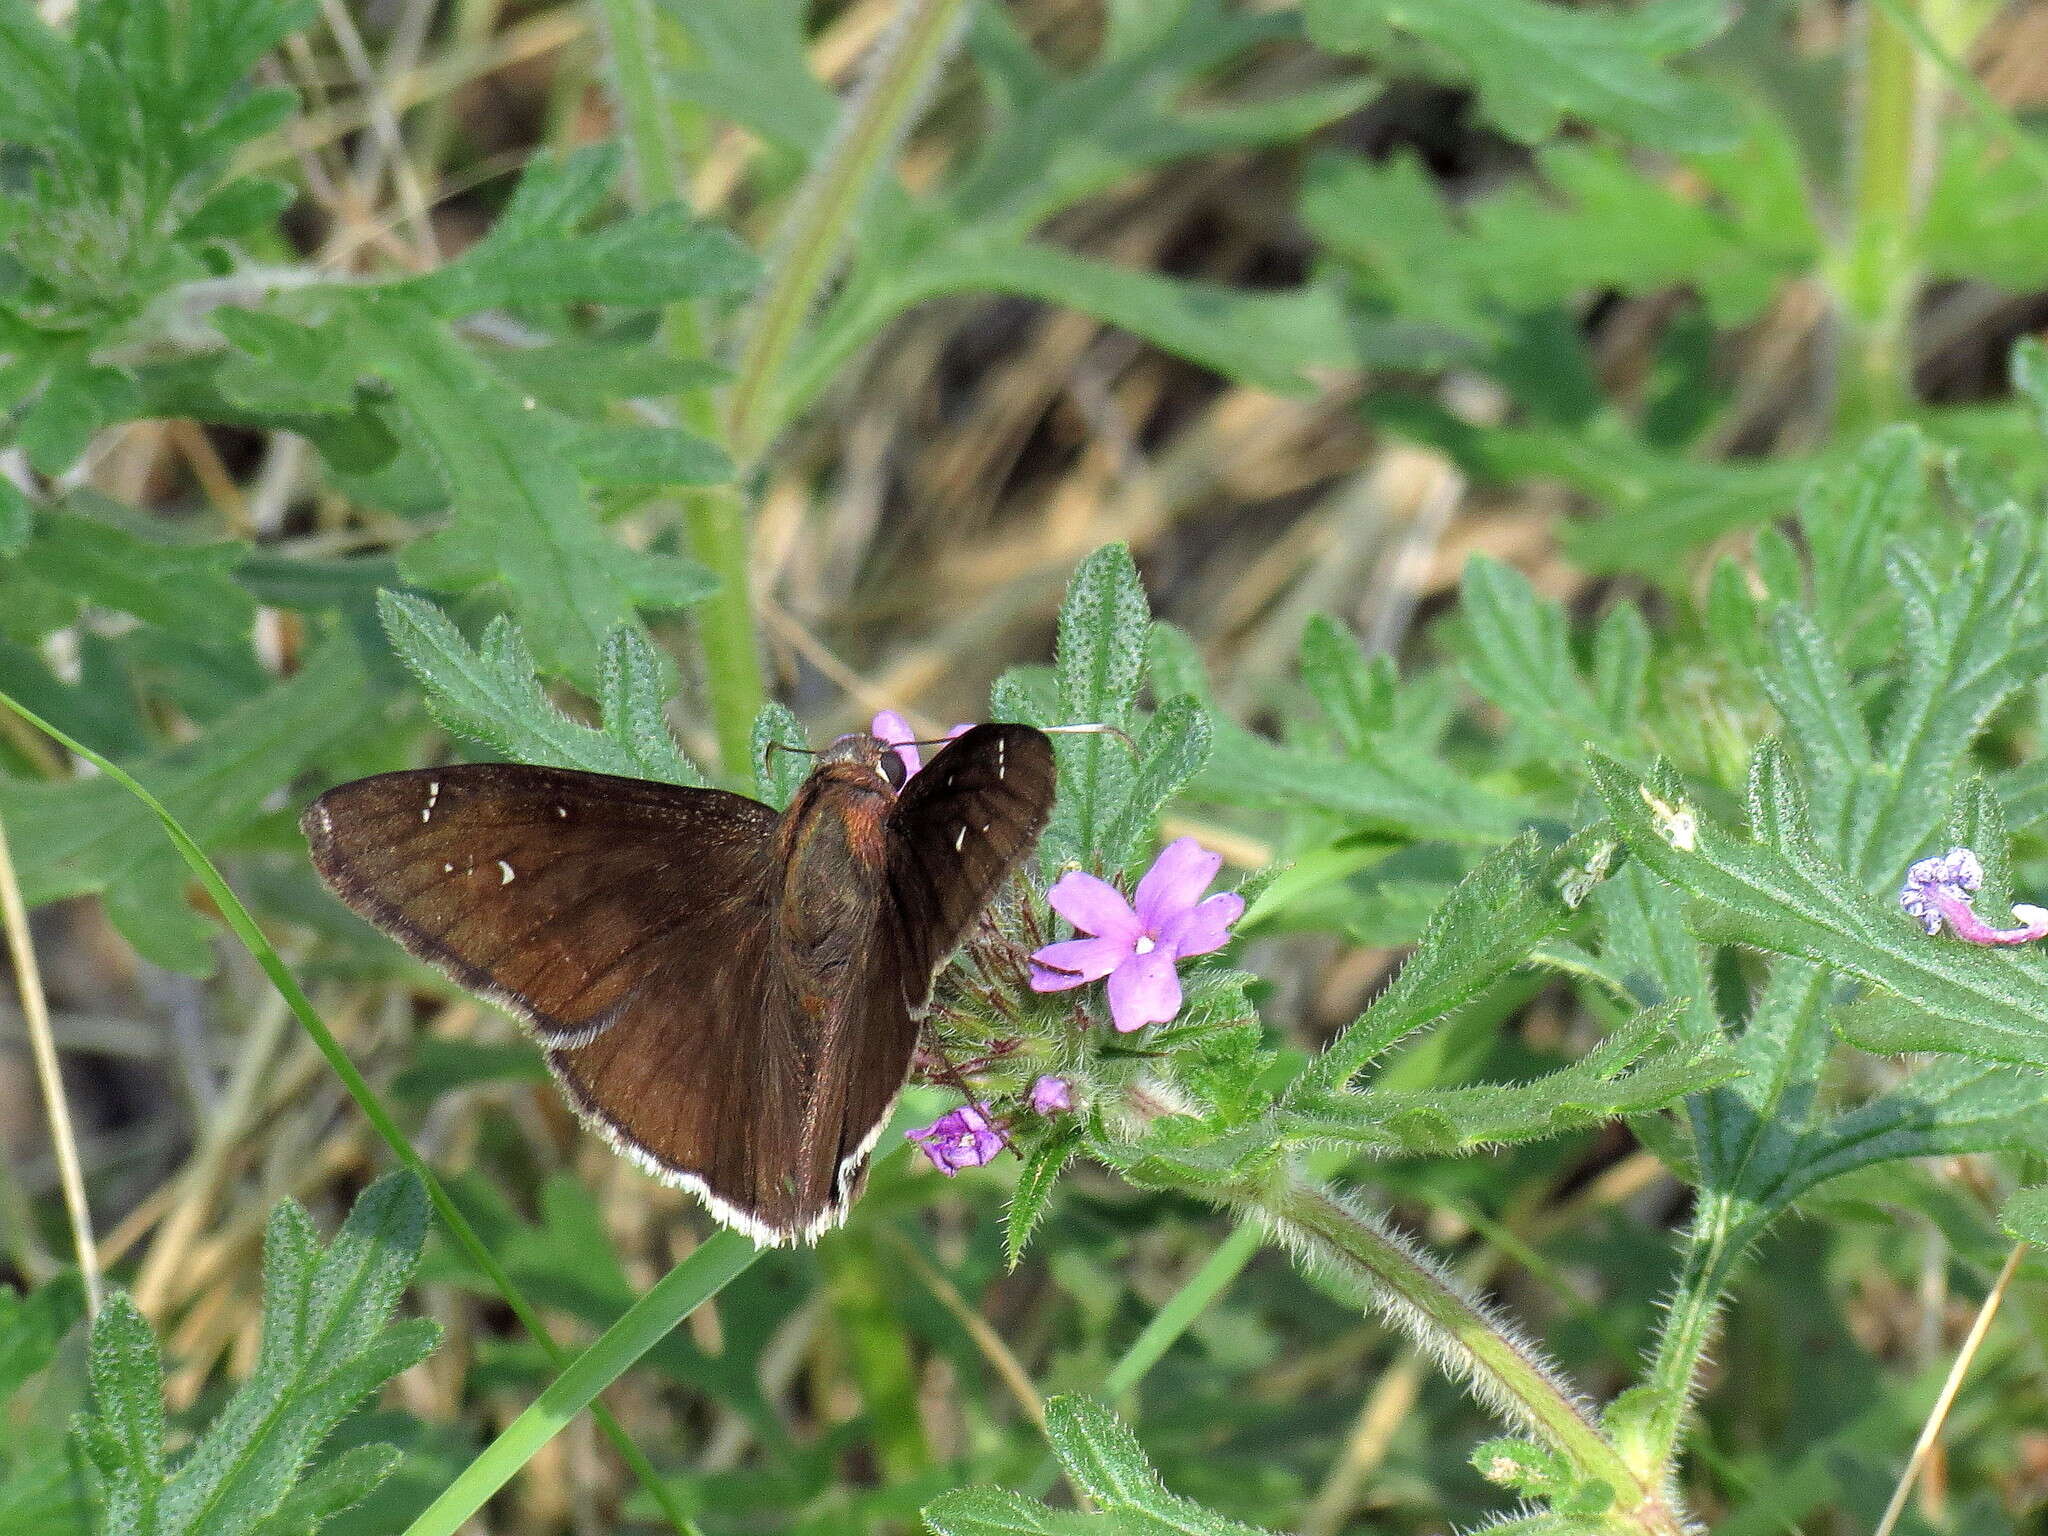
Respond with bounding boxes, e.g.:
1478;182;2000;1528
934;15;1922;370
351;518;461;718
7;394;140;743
303;725;1053;1241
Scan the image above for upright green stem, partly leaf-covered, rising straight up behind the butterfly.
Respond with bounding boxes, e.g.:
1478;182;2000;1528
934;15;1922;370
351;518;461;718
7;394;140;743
602;0;768;776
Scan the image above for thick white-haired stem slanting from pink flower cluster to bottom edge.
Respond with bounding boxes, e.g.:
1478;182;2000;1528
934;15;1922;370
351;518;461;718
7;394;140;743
1236;1174;1688;1536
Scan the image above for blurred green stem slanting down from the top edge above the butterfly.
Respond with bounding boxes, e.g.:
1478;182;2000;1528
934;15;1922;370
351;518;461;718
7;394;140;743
727;0;967;465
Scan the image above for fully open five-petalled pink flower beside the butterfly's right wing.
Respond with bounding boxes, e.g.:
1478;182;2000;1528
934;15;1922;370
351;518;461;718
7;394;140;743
1030;838;1245;1032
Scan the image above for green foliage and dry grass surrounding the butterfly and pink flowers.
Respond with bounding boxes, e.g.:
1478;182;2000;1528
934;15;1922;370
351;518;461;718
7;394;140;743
0;0;2048;1536
